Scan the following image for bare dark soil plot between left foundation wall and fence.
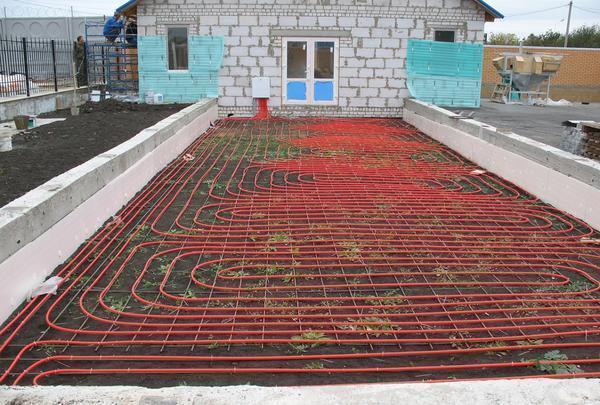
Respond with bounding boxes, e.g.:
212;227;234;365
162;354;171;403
0;100;187;206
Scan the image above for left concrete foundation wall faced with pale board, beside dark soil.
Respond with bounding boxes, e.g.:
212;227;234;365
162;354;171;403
0;99;218;323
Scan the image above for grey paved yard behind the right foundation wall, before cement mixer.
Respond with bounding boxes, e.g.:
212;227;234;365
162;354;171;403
450;100;600;148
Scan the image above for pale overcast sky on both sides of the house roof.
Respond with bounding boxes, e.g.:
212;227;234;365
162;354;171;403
0;0;600;36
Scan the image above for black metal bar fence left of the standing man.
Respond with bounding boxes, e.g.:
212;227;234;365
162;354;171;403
0;38;73;98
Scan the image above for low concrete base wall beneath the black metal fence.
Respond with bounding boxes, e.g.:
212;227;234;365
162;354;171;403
0;87;88;121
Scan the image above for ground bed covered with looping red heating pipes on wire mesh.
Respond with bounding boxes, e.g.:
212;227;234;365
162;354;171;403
0;118;600;386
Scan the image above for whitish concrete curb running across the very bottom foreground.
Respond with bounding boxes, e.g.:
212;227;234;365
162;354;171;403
0;379;600;405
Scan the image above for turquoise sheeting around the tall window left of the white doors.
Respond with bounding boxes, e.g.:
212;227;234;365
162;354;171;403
138;35;223;103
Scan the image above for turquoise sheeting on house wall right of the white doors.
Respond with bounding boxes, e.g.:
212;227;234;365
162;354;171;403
406;39;483;107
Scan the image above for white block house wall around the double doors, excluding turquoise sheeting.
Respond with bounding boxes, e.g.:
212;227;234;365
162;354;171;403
138;0;485;116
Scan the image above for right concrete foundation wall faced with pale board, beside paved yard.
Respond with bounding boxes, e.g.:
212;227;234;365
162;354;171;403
404;100;600;230
